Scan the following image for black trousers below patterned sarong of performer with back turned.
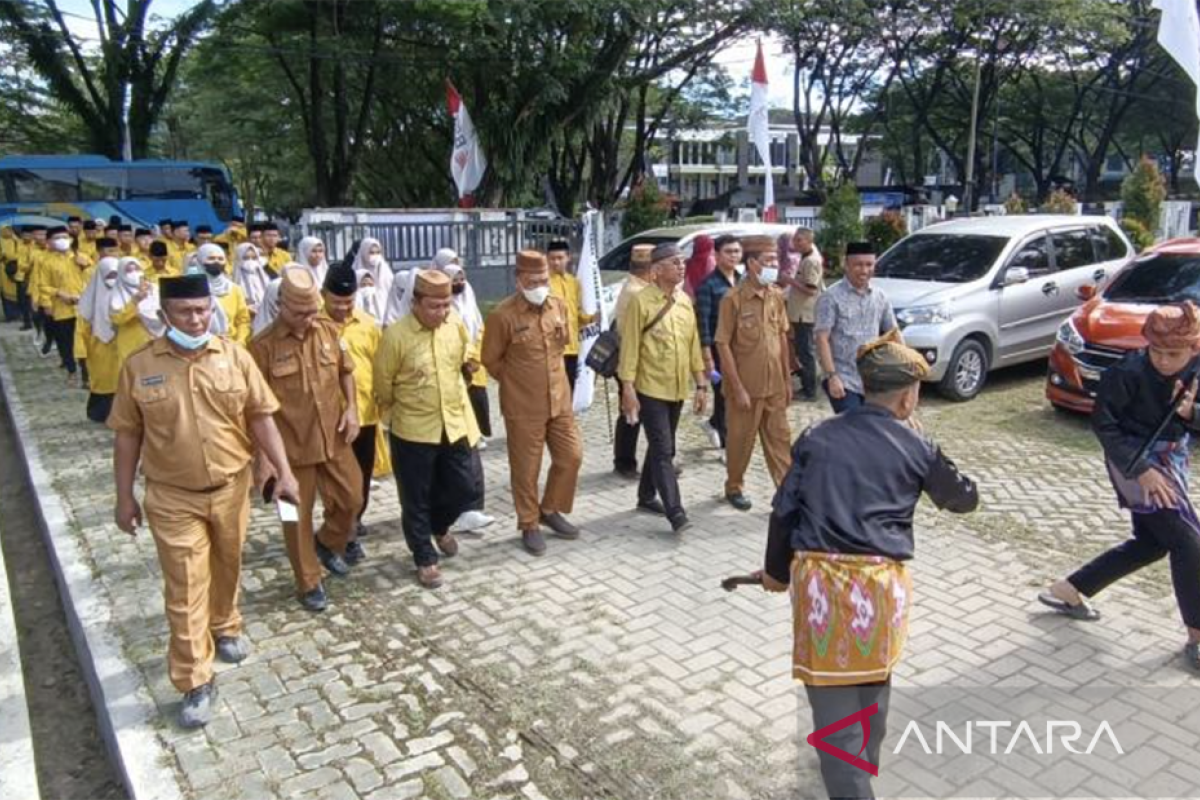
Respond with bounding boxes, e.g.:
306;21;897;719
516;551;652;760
804;680;892;800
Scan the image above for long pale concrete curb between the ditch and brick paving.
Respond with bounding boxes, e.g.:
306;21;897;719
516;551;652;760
0;348;185;800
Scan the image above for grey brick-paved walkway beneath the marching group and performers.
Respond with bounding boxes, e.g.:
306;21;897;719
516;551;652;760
0;332;1196;800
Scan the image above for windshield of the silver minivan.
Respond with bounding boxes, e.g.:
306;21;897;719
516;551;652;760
875;234;1008;283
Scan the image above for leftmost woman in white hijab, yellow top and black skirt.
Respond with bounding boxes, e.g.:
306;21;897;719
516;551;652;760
74;258;120;422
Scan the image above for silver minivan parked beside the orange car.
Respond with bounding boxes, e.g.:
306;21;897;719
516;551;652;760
872;215;1134;401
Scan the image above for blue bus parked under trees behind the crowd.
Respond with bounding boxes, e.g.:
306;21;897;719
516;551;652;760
0;156;241;233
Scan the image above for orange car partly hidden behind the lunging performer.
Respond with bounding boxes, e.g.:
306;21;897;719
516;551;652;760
1046;239;1200;414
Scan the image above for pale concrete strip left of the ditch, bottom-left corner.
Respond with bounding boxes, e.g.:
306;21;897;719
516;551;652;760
0;494;41;800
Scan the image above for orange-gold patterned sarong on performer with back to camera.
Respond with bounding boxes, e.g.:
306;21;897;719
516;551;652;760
792;552;912;686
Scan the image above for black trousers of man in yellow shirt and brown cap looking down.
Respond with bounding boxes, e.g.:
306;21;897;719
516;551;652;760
388;433;478;566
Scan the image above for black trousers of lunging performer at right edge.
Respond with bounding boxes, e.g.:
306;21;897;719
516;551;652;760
1067;509;1200;628
